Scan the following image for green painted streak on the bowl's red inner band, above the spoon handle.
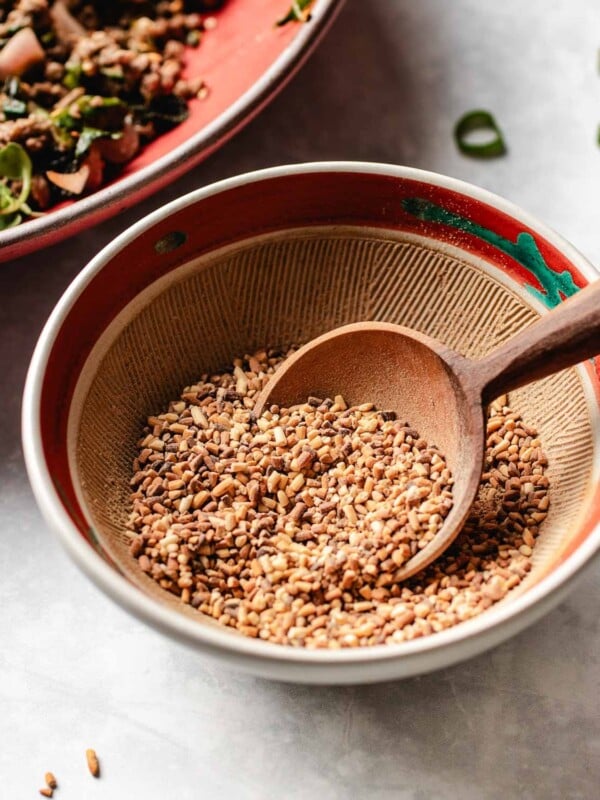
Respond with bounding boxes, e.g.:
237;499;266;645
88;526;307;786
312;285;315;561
403;197;579;308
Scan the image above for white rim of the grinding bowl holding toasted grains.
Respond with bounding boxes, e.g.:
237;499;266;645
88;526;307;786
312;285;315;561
22;161;600;667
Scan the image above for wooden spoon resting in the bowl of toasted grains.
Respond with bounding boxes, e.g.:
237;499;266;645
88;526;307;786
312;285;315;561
255;280;600;578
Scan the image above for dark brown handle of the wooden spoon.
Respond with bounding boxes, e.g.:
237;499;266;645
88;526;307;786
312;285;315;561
472;280;600;404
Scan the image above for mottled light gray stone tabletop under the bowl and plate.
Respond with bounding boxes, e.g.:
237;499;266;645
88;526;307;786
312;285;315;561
0;0;600;800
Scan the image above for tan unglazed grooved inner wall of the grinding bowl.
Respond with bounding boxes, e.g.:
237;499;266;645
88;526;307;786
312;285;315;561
69;228;594;635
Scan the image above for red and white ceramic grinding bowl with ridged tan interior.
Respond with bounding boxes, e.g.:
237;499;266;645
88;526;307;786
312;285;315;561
23;163;600;683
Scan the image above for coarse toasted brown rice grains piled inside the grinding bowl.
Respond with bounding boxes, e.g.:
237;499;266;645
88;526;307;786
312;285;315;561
128;350;548;648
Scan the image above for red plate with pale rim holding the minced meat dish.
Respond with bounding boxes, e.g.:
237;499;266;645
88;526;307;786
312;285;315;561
0;0;343;261
